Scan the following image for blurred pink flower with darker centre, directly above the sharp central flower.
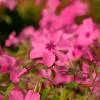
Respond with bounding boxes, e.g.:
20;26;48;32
40;9;59;31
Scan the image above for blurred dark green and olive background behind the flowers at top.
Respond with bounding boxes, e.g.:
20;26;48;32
0;0;100;45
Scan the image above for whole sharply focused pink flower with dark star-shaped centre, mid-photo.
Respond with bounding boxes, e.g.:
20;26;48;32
30;31;67;67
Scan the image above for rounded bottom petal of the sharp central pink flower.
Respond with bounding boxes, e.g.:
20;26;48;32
43;50;55;67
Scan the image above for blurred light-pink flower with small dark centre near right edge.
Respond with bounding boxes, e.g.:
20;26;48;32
76;18;100;46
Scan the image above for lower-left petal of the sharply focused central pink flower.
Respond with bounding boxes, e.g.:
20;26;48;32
30;49;44;59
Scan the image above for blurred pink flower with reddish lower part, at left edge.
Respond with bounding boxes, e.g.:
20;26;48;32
0;49;20;82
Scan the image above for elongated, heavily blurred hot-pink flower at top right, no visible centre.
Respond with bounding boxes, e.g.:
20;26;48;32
59;1;88;25
